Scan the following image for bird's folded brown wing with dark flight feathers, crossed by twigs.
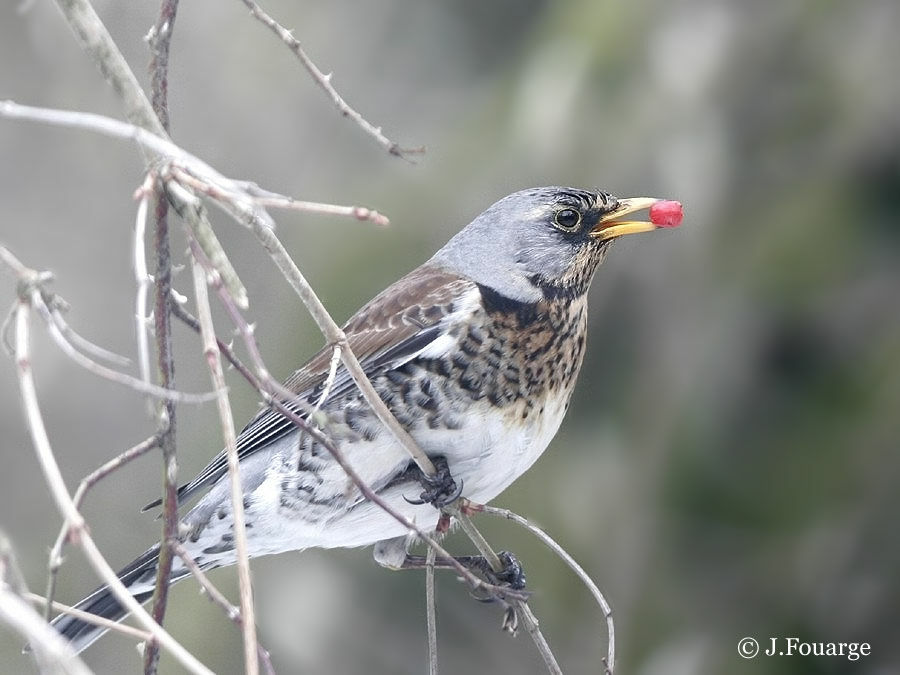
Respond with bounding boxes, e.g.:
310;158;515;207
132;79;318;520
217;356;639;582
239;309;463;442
144;264;475;510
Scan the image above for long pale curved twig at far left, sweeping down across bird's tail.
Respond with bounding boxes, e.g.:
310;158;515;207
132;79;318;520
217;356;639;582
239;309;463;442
15;294;212;675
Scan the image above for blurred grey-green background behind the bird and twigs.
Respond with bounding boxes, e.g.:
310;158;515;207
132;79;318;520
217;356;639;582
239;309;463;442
0;0;900;675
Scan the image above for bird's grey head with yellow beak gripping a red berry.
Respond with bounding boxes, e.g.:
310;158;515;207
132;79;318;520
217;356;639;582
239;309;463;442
432;187;681;302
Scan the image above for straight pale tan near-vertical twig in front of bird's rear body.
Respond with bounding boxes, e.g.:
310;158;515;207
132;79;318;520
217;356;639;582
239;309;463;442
191;252;259;675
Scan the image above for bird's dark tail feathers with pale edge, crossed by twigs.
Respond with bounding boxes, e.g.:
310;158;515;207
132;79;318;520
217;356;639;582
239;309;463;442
51;544;185;652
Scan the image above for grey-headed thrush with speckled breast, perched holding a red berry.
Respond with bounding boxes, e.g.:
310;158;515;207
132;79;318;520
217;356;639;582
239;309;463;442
53;186;681;652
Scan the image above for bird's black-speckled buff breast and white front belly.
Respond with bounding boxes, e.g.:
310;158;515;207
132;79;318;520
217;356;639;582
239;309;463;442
391;298;586;501
